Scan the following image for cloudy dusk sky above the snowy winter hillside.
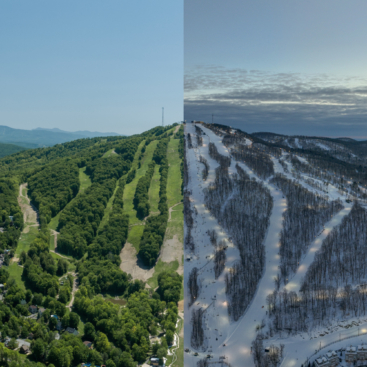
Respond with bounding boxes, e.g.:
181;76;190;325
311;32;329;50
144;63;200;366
184;0;367;138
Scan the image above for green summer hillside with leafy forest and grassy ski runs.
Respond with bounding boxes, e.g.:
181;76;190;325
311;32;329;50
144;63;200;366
0;124;183;367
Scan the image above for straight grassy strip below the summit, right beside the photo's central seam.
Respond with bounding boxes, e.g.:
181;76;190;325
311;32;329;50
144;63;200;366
167;139;182;207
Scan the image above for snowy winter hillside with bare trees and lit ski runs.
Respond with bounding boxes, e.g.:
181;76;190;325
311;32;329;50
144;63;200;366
184;123;367;367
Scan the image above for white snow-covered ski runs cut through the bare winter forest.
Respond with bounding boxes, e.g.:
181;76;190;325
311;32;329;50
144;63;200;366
184;124;351;367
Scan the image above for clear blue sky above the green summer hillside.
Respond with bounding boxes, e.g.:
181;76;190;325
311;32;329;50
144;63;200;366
0;0;183;135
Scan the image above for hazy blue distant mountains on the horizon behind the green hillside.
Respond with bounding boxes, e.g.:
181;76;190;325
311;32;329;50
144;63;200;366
0;125;120;148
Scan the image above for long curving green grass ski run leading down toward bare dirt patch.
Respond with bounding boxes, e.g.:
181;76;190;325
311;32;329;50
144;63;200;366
124;140;158;224
